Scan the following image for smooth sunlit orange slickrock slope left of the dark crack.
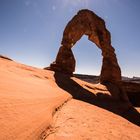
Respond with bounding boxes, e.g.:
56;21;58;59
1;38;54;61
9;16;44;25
0;58;70;140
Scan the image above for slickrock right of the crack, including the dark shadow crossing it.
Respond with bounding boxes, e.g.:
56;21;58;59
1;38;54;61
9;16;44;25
44;75;140;140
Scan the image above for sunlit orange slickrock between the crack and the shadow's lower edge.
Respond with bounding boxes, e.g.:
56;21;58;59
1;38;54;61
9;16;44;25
46;99;140;140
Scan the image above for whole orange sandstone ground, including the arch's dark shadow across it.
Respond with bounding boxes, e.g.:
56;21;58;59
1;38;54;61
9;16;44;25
0;57;140;140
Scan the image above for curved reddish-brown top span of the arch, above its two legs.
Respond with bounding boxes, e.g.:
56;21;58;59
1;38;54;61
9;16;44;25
62;10;111;48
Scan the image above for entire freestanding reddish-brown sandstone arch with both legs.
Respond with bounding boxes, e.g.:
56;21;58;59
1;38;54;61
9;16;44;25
50;9;121;83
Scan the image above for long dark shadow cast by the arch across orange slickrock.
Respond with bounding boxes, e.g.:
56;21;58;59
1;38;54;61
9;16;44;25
54;72;140;126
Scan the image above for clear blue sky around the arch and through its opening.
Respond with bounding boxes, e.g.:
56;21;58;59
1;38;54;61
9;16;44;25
0;0;140;77
